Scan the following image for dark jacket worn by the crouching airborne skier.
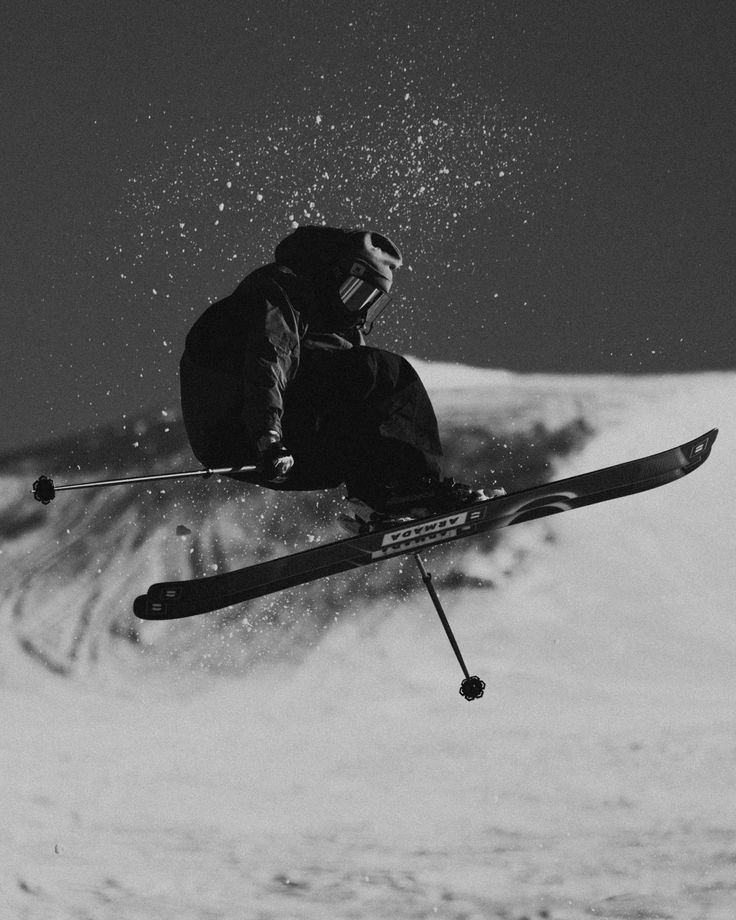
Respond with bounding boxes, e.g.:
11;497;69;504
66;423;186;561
180;263;364;466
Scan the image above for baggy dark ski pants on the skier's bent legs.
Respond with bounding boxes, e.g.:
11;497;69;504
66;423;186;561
185;346;442;510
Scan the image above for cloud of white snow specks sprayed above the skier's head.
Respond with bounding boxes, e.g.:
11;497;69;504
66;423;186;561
109;68;572;364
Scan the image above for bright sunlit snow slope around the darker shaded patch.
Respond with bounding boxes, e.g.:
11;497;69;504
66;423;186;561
0;365;736;920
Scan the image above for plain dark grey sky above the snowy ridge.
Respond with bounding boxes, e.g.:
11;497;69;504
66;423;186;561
0;0;736;448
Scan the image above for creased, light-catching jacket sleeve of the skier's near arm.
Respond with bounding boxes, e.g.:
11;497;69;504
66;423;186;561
236;277;300;439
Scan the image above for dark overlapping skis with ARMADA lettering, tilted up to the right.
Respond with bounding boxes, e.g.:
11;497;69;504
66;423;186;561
134;429;718;620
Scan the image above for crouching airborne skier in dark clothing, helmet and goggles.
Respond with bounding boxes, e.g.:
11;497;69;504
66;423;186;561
180;226;486;525
